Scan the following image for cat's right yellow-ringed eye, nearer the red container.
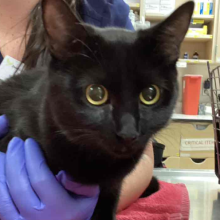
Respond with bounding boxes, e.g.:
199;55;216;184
140;85;160;105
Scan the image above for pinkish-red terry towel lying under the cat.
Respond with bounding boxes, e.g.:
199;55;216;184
117;181;189;220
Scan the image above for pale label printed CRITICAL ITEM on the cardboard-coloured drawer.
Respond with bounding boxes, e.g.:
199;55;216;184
180;138;215;151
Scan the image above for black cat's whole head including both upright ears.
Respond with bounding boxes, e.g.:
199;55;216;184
42;0;194;182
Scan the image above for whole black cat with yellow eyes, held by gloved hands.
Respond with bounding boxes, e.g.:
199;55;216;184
0;0;194;220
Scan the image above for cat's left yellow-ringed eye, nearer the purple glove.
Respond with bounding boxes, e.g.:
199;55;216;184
86;84;108;105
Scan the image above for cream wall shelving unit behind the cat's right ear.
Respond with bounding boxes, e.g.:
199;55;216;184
126;0;220;64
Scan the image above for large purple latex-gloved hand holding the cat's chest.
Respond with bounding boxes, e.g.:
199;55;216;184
0;138;99;220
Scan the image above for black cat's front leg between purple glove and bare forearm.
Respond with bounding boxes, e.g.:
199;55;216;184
92;181;121;220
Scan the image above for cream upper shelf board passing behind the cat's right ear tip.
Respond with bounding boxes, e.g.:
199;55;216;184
146;14;214;23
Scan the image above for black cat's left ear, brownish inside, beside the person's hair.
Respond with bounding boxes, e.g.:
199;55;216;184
42;0;87;59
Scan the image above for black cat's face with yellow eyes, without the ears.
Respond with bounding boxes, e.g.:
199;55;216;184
47;29;177;157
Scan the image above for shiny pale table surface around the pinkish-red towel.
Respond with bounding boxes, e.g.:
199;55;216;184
154;169;220;220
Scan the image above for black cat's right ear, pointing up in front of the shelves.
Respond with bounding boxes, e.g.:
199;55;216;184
154;1;194;63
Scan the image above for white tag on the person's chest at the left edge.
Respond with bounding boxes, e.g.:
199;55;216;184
0;56;24;80
